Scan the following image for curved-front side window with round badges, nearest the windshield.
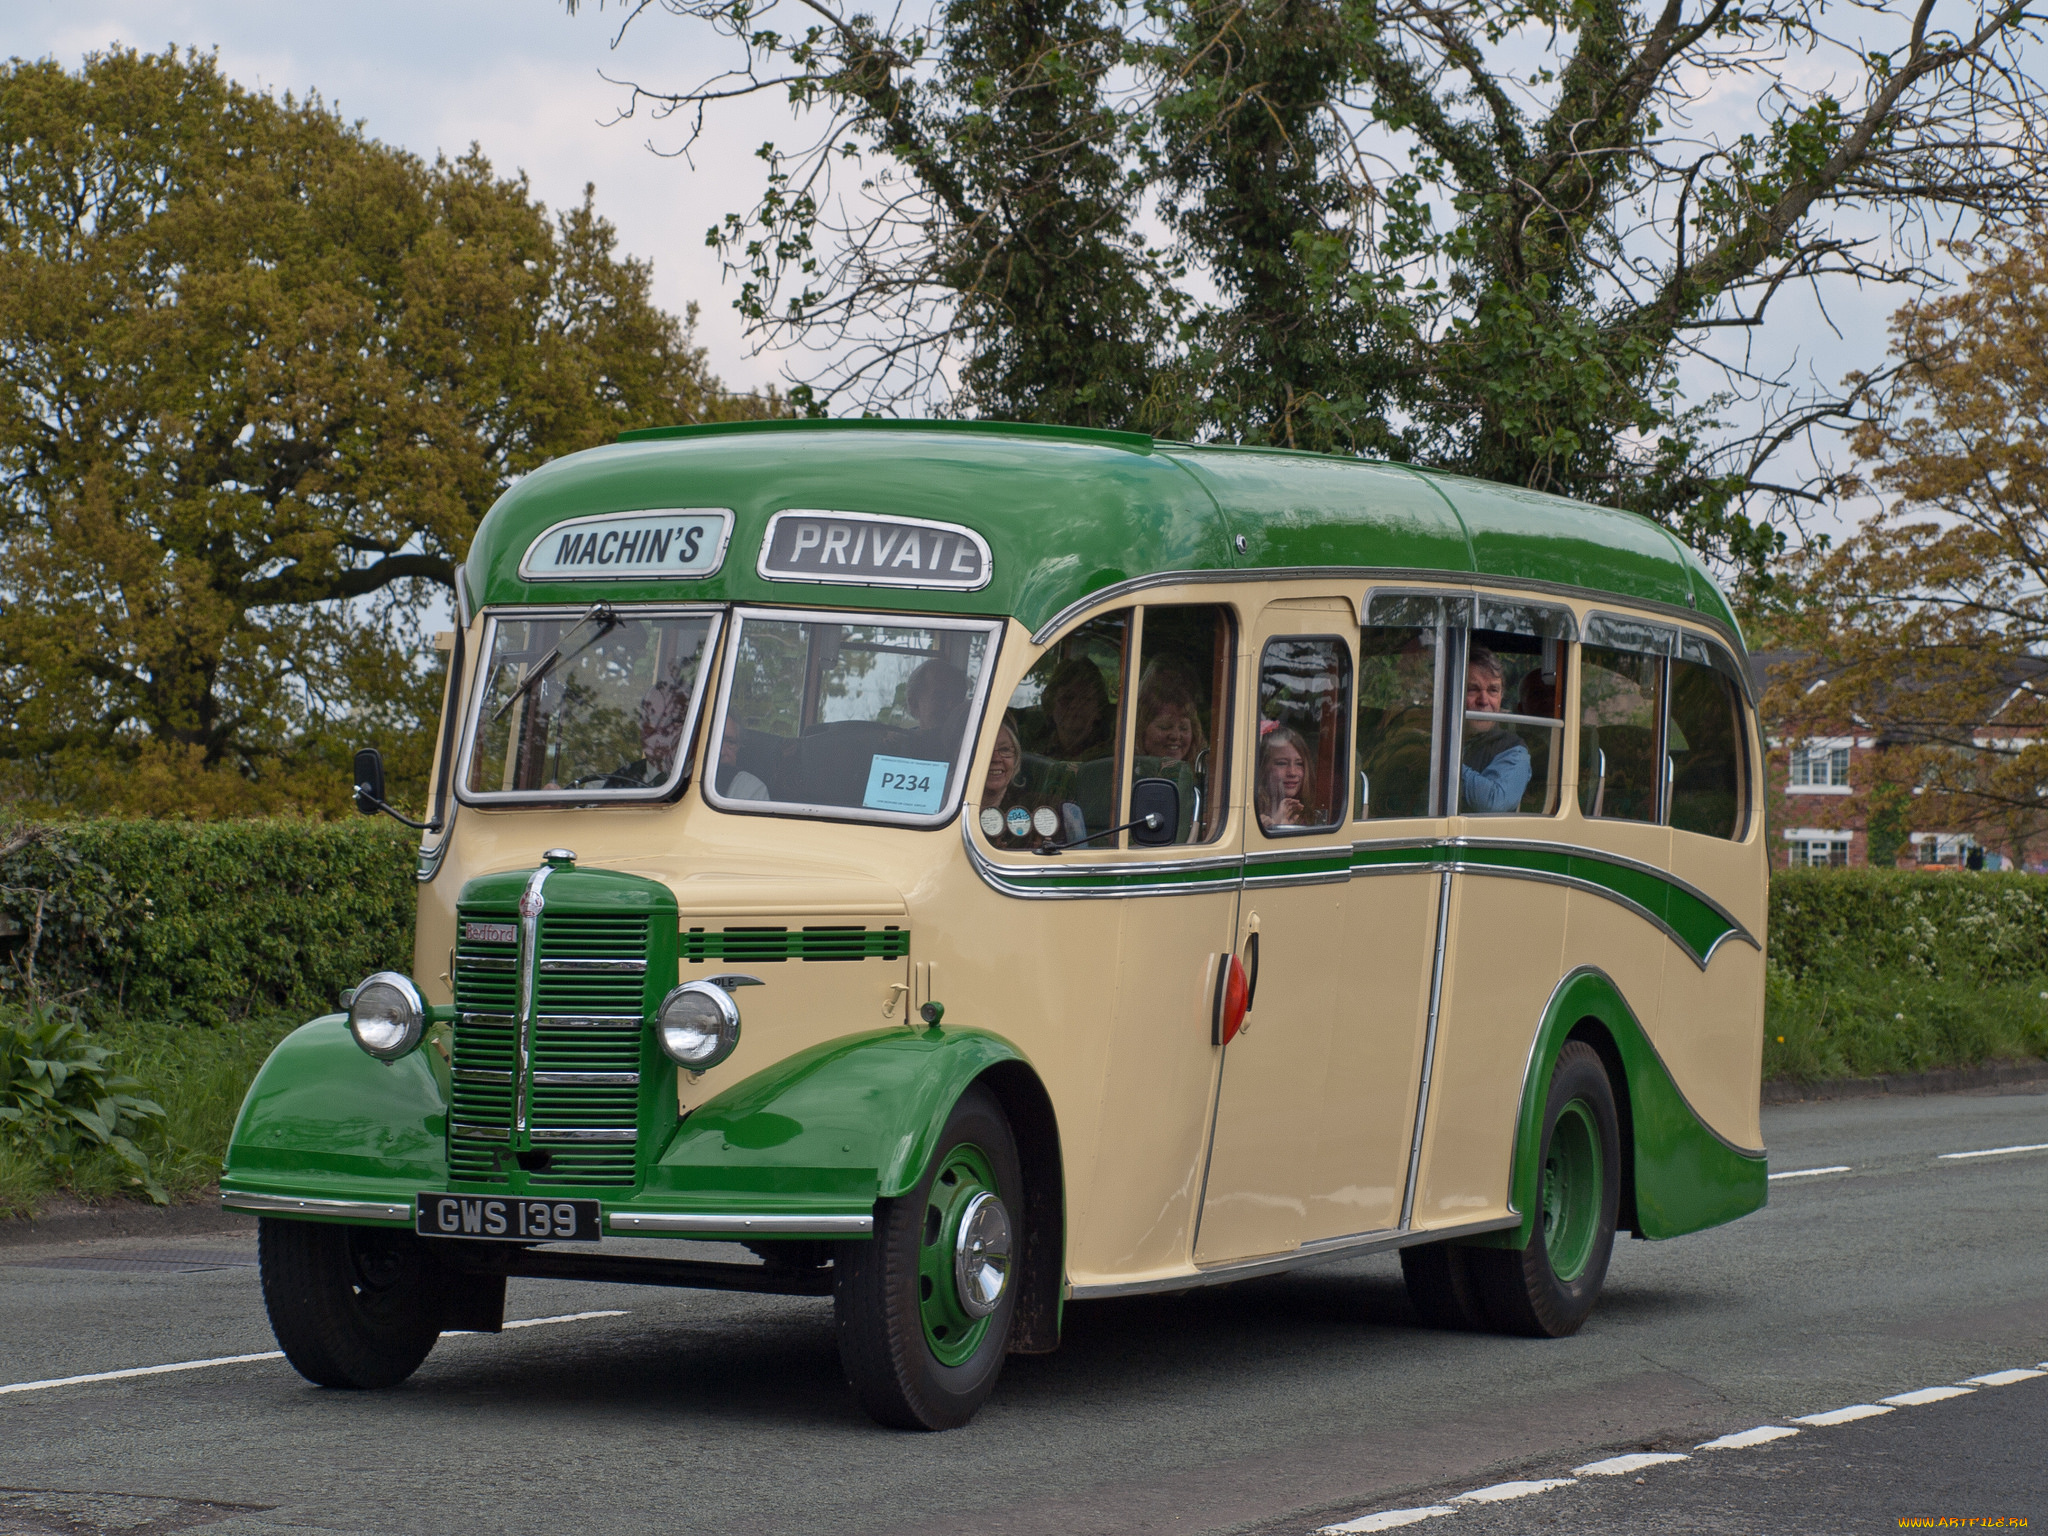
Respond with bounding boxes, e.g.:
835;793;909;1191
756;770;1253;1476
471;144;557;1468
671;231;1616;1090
979;608;1130;848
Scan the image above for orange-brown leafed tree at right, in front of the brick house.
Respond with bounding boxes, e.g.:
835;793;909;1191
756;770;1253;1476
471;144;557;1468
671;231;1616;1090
1772;221;2048;846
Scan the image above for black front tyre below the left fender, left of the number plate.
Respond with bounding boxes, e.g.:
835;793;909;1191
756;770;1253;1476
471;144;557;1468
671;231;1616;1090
256;1217;440;1389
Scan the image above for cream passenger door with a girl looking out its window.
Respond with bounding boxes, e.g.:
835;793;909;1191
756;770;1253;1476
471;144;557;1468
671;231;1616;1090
1194;598;1356;1264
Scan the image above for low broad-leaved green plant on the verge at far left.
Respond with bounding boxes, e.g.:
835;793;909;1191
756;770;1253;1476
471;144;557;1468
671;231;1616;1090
0;1001;168;1204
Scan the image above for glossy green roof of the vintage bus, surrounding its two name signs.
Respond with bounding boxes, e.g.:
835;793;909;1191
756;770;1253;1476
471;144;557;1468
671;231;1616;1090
465;420;1741;647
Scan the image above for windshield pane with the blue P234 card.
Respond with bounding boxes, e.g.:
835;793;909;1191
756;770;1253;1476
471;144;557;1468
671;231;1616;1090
705;612;995;825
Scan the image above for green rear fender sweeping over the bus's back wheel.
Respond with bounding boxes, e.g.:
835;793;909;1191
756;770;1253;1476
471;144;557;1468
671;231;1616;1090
1470;967;1769;1247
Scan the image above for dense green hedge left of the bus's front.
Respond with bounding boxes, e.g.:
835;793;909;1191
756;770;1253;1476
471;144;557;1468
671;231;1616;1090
0;819;418;1024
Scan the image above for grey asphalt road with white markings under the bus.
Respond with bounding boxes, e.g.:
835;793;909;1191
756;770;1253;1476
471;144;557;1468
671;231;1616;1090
0;1092;2048;1536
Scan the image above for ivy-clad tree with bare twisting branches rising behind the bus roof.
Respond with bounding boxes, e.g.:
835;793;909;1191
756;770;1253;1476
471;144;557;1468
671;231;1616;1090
565;0;2048;571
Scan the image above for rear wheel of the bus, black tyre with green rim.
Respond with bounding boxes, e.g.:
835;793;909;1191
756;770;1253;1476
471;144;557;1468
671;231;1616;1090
1464;1040;1622;1339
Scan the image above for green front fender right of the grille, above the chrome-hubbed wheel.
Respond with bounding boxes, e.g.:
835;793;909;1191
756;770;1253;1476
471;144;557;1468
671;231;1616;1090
643;1028;1024;1210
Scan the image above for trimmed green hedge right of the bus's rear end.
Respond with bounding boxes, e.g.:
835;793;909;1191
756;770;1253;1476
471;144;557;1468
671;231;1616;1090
1769;868;2048;981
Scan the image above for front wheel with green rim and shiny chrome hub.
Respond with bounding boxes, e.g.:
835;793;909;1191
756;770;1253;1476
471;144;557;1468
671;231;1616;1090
834;1087;1024;1430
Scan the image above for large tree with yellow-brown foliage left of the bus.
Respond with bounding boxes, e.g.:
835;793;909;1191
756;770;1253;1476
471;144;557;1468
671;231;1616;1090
0;51;776;813
